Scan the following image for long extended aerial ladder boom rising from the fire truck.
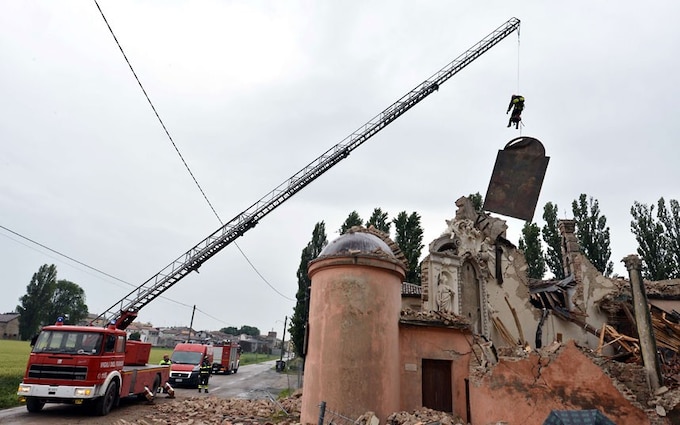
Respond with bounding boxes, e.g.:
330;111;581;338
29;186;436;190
95;18;520;329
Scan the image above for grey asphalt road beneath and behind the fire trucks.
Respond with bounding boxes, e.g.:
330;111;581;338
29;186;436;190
0;361;299;425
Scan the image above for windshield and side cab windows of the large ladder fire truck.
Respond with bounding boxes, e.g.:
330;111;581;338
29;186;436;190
33;331;103;355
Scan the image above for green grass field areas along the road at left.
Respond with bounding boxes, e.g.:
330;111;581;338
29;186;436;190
0;339;278;409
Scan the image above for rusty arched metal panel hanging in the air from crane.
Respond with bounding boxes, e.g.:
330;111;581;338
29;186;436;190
484;137;550;222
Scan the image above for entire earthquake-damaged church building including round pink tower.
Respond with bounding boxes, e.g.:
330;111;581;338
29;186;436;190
301;197;680;425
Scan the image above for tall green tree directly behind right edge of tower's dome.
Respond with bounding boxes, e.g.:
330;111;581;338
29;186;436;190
393;211;423;285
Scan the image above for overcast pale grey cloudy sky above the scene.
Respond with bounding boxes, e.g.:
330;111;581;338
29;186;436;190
0;0;680;335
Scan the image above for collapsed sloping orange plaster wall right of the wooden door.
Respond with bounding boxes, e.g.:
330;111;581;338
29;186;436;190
470;341;651;425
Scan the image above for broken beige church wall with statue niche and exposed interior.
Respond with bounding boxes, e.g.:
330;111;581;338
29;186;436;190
422;213;616;352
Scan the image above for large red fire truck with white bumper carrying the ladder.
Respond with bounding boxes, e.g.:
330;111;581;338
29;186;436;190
18;319;174;416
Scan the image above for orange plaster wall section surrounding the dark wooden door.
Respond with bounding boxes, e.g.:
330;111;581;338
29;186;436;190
399;324;472;418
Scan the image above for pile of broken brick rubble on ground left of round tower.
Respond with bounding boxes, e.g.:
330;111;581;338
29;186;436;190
115;391;302;425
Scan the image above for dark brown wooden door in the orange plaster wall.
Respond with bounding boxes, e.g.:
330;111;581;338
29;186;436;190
422;359;453;412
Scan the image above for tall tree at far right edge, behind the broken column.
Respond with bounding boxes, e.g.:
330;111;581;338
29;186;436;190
630;198;680;280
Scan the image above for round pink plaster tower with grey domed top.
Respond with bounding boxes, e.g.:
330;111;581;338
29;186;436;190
300;228;405;424
